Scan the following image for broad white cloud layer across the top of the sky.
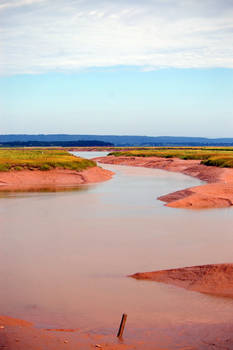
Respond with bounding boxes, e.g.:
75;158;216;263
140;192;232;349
0;0;233;75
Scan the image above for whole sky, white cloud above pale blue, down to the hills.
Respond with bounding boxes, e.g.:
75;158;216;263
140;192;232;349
0;0;233;137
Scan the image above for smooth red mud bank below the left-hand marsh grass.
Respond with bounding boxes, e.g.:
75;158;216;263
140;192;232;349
0;166;113;191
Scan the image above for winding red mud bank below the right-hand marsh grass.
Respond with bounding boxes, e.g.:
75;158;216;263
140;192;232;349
95;156;233;209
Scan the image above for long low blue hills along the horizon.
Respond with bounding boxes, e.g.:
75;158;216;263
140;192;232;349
0;134;233;146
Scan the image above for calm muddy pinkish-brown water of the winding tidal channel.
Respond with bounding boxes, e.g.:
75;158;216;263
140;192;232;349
0;152;233;333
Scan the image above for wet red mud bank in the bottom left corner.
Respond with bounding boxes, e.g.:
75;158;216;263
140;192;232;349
0;316;132;350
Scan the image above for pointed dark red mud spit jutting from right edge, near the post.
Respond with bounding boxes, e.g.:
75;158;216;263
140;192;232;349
129;264;233;298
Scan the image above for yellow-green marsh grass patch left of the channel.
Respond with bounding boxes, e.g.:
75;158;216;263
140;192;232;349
0;148;96;171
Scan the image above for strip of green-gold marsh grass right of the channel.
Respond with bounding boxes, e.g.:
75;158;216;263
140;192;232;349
109;147;233;168
